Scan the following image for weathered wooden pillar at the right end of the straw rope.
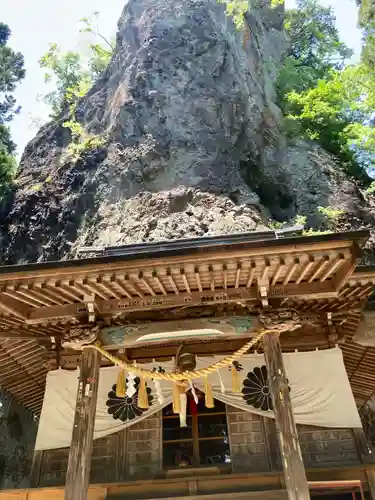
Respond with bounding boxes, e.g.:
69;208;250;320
263;333;310;500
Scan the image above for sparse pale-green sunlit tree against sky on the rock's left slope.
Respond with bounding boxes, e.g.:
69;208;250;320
39;12;114;116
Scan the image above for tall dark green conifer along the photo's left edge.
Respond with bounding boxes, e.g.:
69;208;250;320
0;23;25;199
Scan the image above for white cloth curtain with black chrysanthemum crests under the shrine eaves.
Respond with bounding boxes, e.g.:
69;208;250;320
35;348;361;450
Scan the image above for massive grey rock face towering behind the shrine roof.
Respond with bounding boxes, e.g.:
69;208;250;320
1;0;374;263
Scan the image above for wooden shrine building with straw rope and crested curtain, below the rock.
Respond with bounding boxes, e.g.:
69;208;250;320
0;228;375;500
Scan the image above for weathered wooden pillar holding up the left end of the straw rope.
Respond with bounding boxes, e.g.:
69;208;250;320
64;349;100;500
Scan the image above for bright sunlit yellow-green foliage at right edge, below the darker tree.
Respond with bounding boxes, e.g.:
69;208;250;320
287;66;375;184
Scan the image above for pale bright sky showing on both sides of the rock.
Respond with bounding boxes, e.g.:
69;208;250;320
0;0;361;154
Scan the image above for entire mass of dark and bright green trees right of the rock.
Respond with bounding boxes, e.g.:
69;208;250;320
276;0;375;185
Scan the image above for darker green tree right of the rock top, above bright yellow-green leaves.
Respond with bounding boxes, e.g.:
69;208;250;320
276;0;352;109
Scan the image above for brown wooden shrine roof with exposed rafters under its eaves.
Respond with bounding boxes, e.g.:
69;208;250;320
0;231;375;413
